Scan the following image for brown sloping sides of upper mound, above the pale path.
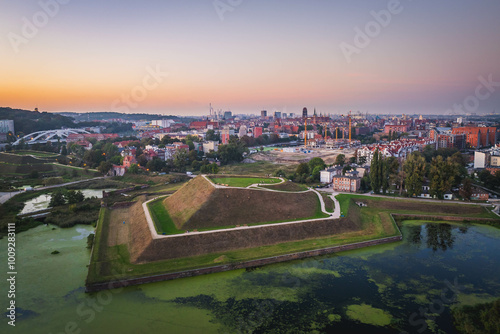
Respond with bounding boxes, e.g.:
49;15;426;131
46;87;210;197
155;176;328;231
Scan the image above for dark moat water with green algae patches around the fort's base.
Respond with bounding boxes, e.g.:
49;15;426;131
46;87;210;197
0;222;500;334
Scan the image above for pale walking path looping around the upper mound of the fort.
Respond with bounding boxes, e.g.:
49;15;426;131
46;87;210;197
142;175;340;239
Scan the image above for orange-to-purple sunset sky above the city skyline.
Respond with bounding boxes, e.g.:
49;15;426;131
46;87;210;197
0;0;500;115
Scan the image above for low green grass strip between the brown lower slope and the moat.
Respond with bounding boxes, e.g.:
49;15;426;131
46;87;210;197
89;194;500;283
